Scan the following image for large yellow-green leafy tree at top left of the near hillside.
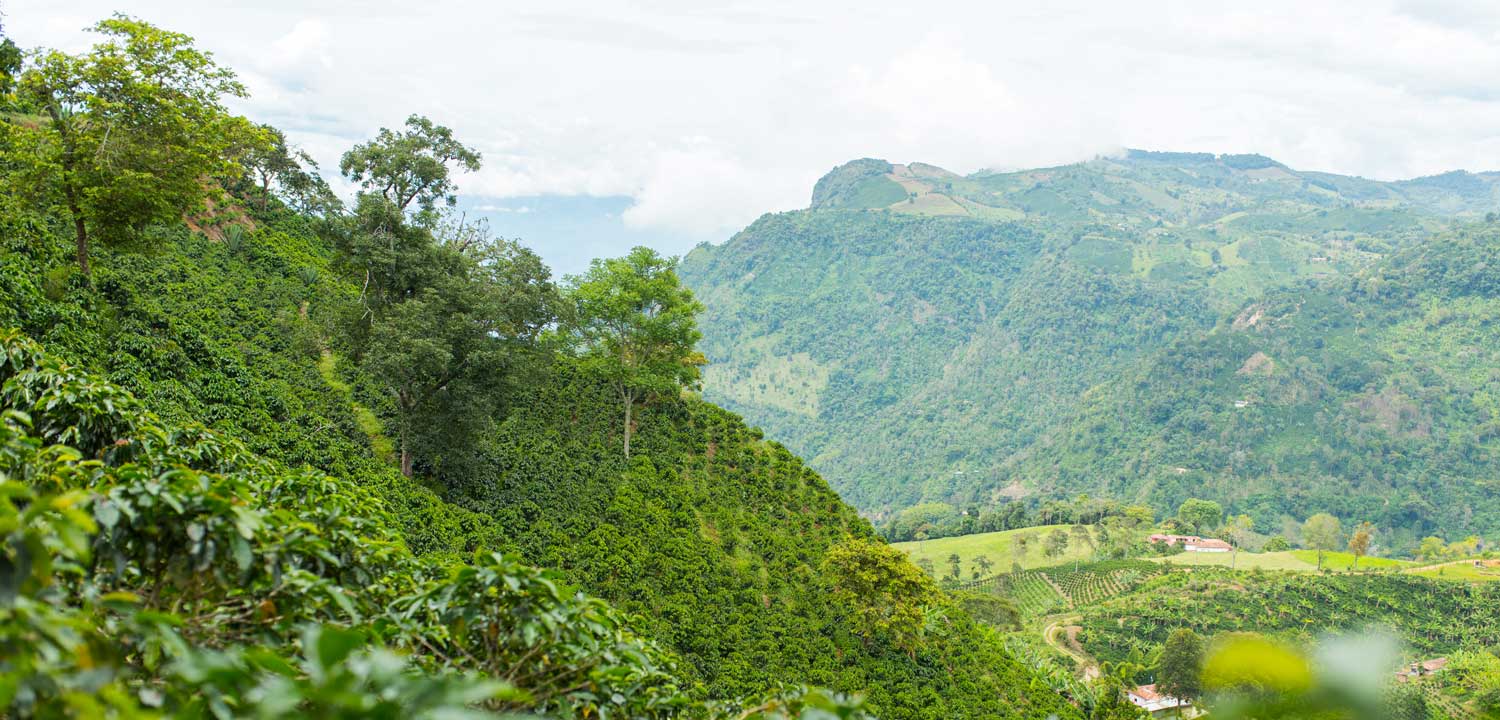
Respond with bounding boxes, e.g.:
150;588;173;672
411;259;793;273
11;15;251;276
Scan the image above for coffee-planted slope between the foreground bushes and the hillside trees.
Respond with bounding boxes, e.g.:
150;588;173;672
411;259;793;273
0;193;1071;719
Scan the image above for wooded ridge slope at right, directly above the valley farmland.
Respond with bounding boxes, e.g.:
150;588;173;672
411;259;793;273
1007;224;1500;546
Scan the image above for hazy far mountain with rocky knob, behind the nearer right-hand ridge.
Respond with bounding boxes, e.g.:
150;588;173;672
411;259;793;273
683;152;1500;515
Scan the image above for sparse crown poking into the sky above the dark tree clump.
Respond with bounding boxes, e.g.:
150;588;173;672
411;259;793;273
339;116;480;216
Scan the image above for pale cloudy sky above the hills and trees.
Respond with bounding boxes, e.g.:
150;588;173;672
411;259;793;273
11;0;1500;273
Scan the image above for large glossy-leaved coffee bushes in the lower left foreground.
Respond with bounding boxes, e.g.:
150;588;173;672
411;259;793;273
0;332;683;717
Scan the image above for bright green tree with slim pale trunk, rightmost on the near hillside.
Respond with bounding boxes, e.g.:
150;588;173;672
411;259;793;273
570;248;705;458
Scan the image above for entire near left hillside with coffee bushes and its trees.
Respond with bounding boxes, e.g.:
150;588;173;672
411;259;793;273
0;18;1076;719
